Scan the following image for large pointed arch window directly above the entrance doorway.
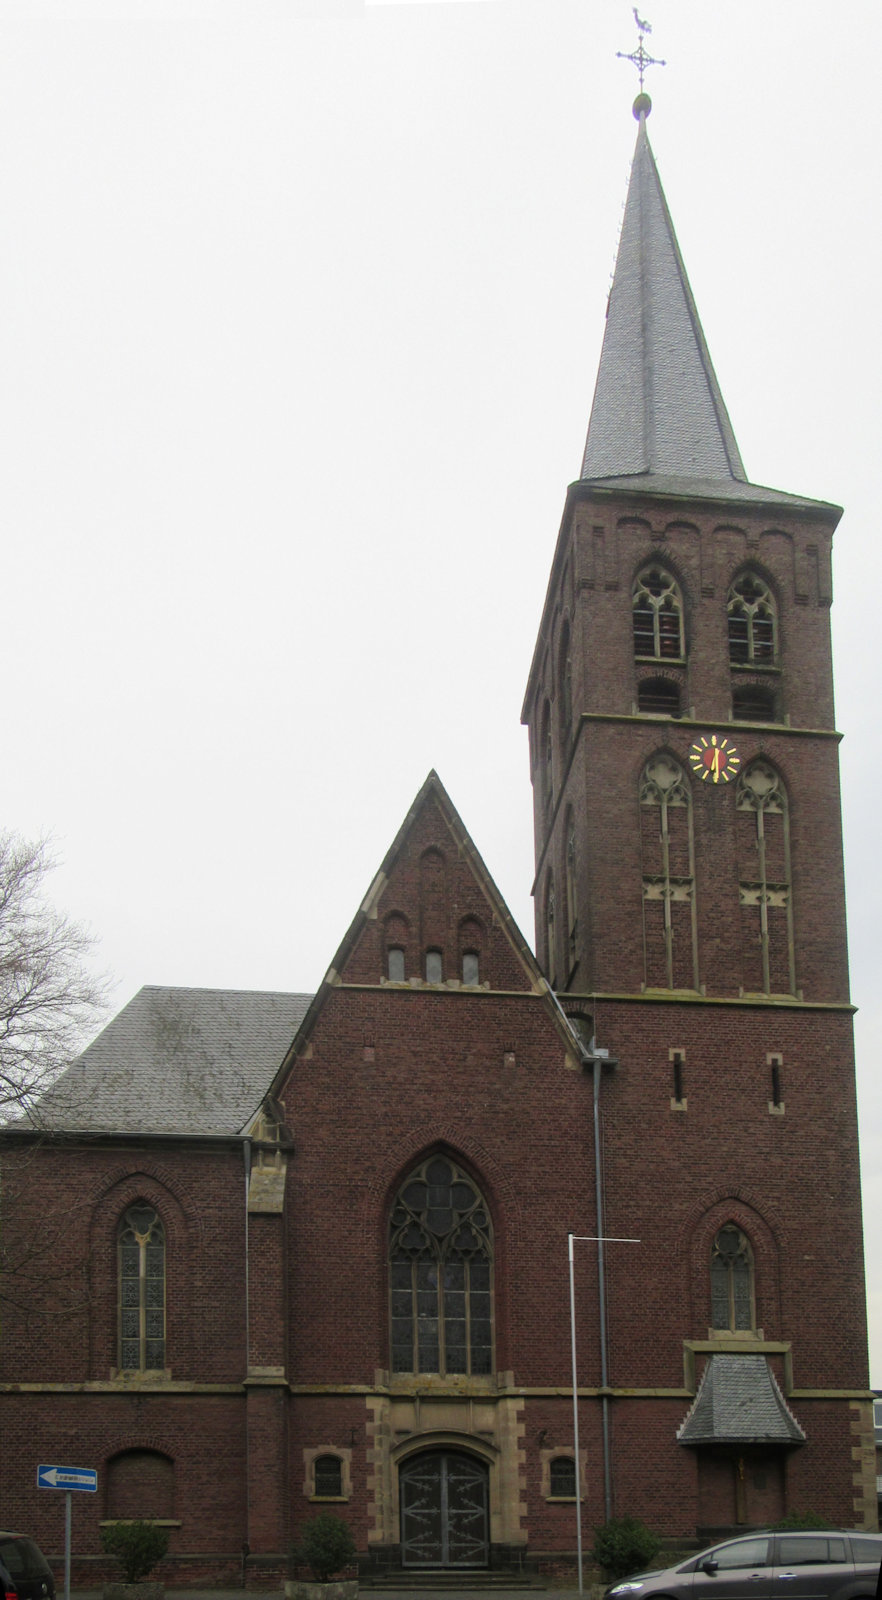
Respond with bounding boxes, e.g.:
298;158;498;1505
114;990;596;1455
389;1155;493;1374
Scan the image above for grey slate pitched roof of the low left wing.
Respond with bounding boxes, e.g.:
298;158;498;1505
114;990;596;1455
34;986;312;1136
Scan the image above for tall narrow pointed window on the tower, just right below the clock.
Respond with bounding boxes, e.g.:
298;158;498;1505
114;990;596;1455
735;760;796;994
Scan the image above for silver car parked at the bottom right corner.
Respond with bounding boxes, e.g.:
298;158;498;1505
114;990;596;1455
605;1528;882;1600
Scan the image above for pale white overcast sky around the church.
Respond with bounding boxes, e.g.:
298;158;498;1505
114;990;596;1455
0;0;882;1386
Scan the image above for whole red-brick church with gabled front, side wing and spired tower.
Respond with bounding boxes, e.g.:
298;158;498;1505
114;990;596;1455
0;96;877;1586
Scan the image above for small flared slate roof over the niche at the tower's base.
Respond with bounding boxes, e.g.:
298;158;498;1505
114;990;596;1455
677;1354;805;1445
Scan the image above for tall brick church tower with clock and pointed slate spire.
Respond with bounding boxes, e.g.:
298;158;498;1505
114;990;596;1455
523;106;876;1530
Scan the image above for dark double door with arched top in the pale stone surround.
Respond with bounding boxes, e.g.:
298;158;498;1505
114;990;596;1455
399;1450;490;1566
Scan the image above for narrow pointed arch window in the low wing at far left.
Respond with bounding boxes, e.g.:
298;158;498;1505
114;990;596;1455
117;1205;165;1373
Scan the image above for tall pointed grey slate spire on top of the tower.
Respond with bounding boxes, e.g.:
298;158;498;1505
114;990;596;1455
581;110;748;483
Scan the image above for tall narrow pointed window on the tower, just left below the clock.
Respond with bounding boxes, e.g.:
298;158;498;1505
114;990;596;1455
640;752;698;989
